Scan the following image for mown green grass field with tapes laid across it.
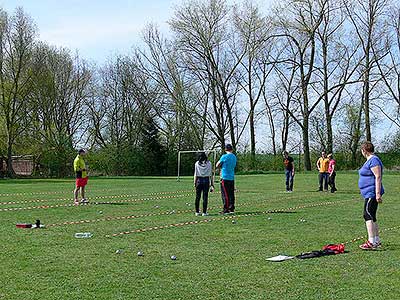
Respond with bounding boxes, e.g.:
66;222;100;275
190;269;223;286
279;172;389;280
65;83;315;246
0;173;400;300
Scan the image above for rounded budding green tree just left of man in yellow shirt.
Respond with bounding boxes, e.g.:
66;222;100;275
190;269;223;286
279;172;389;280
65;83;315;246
27;44;92;176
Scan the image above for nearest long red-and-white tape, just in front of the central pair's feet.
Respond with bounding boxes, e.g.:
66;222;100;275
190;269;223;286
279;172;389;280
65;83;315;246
106;200;350;238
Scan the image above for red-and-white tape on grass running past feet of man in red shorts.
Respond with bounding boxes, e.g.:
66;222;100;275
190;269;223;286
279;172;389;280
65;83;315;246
0;193;193;212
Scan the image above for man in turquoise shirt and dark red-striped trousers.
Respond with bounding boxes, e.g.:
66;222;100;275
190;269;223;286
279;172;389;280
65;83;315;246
216;144;237;214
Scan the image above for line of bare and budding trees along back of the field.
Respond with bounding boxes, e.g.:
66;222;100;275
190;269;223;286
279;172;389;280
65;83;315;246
0;0;400;176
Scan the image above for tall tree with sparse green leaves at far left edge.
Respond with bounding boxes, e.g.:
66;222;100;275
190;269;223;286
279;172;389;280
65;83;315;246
0;8;35;177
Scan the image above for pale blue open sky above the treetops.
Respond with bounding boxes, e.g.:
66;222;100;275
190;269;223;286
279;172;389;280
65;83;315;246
0;0;273;63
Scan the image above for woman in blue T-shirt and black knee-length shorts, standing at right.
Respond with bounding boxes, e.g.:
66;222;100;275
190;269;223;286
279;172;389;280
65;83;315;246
358;142;385;250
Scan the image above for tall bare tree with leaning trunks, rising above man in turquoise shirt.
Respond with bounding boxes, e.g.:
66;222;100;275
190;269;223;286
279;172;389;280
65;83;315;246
169;0;246;148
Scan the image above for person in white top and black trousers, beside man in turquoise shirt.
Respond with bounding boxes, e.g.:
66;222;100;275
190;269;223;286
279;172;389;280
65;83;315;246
194;152;214;217
